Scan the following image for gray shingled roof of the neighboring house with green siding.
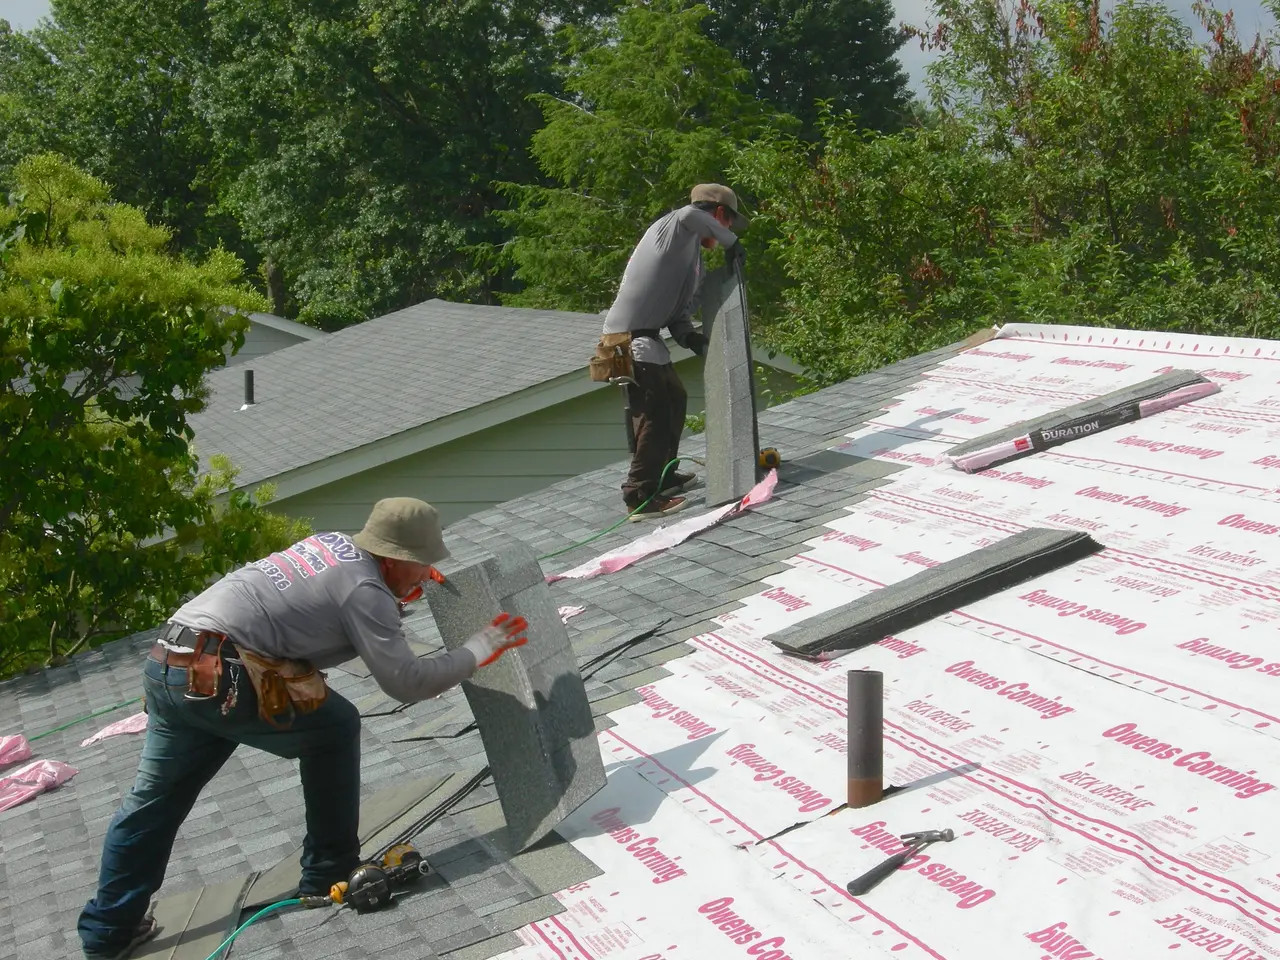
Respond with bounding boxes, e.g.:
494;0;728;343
191;300;600;497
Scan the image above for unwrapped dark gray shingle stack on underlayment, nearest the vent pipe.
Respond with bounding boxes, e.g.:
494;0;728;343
769;527;1102;657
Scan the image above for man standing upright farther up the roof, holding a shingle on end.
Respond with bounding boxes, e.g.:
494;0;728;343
600;183;748;520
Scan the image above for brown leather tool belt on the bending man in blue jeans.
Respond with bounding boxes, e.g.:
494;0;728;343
151;623;329;730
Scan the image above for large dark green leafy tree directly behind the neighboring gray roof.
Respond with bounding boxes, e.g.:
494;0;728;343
200;0;607;328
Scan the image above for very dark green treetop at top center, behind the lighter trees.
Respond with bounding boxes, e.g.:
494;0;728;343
707;0;911;138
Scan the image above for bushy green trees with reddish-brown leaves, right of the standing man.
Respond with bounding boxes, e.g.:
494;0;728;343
739;0;1280;381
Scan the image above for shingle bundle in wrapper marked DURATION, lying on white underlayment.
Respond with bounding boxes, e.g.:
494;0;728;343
947;370;1221;474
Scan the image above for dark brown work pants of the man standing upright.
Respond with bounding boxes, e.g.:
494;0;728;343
622;362;689;509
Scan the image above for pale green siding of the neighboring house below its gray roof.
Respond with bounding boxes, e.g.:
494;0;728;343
273;358;786;532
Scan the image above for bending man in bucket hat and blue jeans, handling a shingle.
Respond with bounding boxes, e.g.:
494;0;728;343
78;497;525;960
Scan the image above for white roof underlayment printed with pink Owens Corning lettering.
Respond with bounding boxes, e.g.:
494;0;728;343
491;325;1280;960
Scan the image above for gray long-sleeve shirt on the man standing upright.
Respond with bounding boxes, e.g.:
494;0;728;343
604;205;737;364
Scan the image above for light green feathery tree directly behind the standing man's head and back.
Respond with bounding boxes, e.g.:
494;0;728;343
495;0;794;317
